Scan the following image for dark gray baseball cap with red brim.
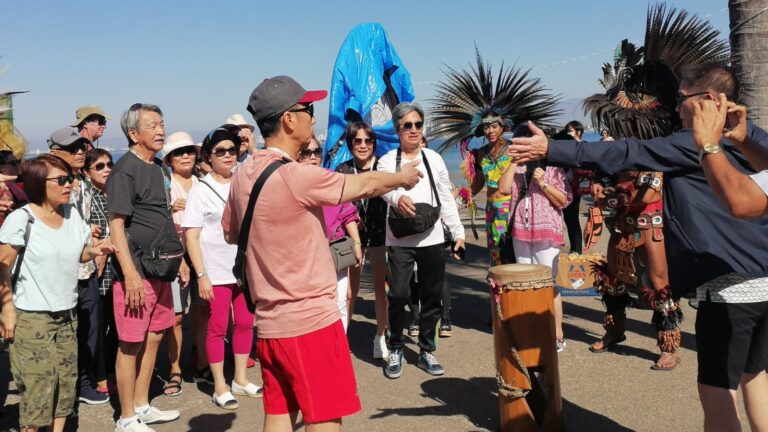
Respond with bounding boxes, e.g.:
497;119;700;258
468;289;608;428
246;75;328;121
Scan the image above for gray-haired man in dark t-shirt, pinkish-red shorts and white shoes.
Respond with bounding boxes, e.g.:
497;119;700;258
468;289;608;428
107;103;183;432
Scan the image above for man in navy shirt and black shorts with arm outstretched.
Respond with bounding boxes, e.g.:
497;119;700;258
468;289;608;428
509;65;768;431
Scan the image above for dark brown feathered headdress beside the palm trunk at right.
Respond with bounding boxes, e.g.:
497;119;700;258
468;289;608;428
582;3;729;139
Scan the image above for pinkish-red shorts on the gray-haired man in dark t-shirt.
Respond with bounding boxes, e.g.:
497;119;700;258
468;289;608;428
112;279;176;342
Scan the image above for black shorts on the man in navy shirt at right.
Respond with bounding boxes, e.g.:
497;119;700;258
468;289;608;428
696;301;768;390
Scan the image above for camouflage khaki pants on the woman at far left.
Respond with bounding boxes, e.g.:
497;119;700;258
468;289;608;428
11;309;77;429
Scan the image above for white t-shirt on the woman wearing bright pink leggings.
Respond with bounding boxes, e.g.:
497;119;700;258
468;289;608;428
181;174;237;285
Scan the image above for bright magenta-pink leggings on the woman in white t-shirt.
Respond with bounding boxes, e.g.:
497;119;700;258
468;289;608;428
205;284;253;363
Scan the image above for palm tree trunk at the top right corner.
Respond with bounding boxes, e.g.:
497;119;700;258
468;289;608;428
728;0;768;130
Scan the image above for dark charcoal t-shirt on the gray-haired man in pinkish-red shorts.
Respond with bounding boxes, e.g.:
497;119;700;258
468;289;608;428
107;152;171;250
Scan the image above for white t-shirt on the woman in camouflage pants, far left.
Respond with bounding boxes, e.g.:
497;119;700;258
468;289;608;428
0;204;91;312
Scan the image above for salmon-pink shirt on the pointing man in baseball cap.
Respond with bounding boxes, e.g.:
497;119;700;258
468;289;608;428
221;150;344;338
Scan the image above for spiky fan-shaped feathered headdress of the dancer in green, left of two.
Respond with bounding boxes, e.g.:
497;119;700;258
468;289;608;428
430;47;560;153
